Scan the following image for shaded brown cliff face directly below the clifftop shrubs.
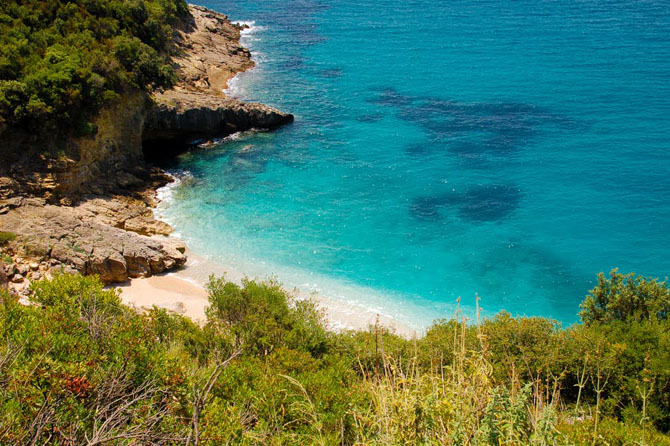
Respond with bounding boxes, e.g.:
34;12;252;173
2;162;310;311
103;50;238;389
0;92;148;202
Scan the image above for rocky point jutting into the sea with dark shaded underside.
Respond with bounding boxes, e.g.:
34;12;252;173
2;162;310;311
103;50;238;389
142;5;293;152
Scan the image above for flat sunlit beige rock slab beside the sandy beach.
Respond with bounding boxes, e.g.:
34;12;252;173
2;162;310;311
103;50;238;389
0;203;186;283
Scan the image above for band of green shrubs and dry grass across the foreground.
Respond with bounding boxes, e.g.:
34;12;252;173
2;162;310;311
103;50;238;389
0;272;670;445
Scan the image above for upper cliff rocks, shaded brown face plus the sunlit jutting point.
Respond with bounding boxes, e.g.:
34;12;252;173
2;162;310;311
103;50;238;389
0;5;293;204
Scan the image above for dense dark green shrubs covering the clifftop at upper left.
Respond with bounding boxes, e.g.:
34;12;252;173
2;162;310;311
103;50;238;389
0;0;188;133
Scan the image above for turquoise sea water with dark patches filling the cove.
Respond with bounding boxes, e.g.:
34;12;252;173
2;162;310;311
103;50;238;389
161;0;670;327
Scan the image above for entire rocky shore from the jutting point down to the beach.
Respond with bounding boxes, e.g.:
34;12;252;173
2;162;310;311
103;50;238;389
0;5;293;293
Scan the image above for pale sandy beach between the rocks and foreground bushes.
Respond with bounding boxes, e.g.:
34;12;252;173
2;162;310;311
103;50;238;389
117;246;419;338
